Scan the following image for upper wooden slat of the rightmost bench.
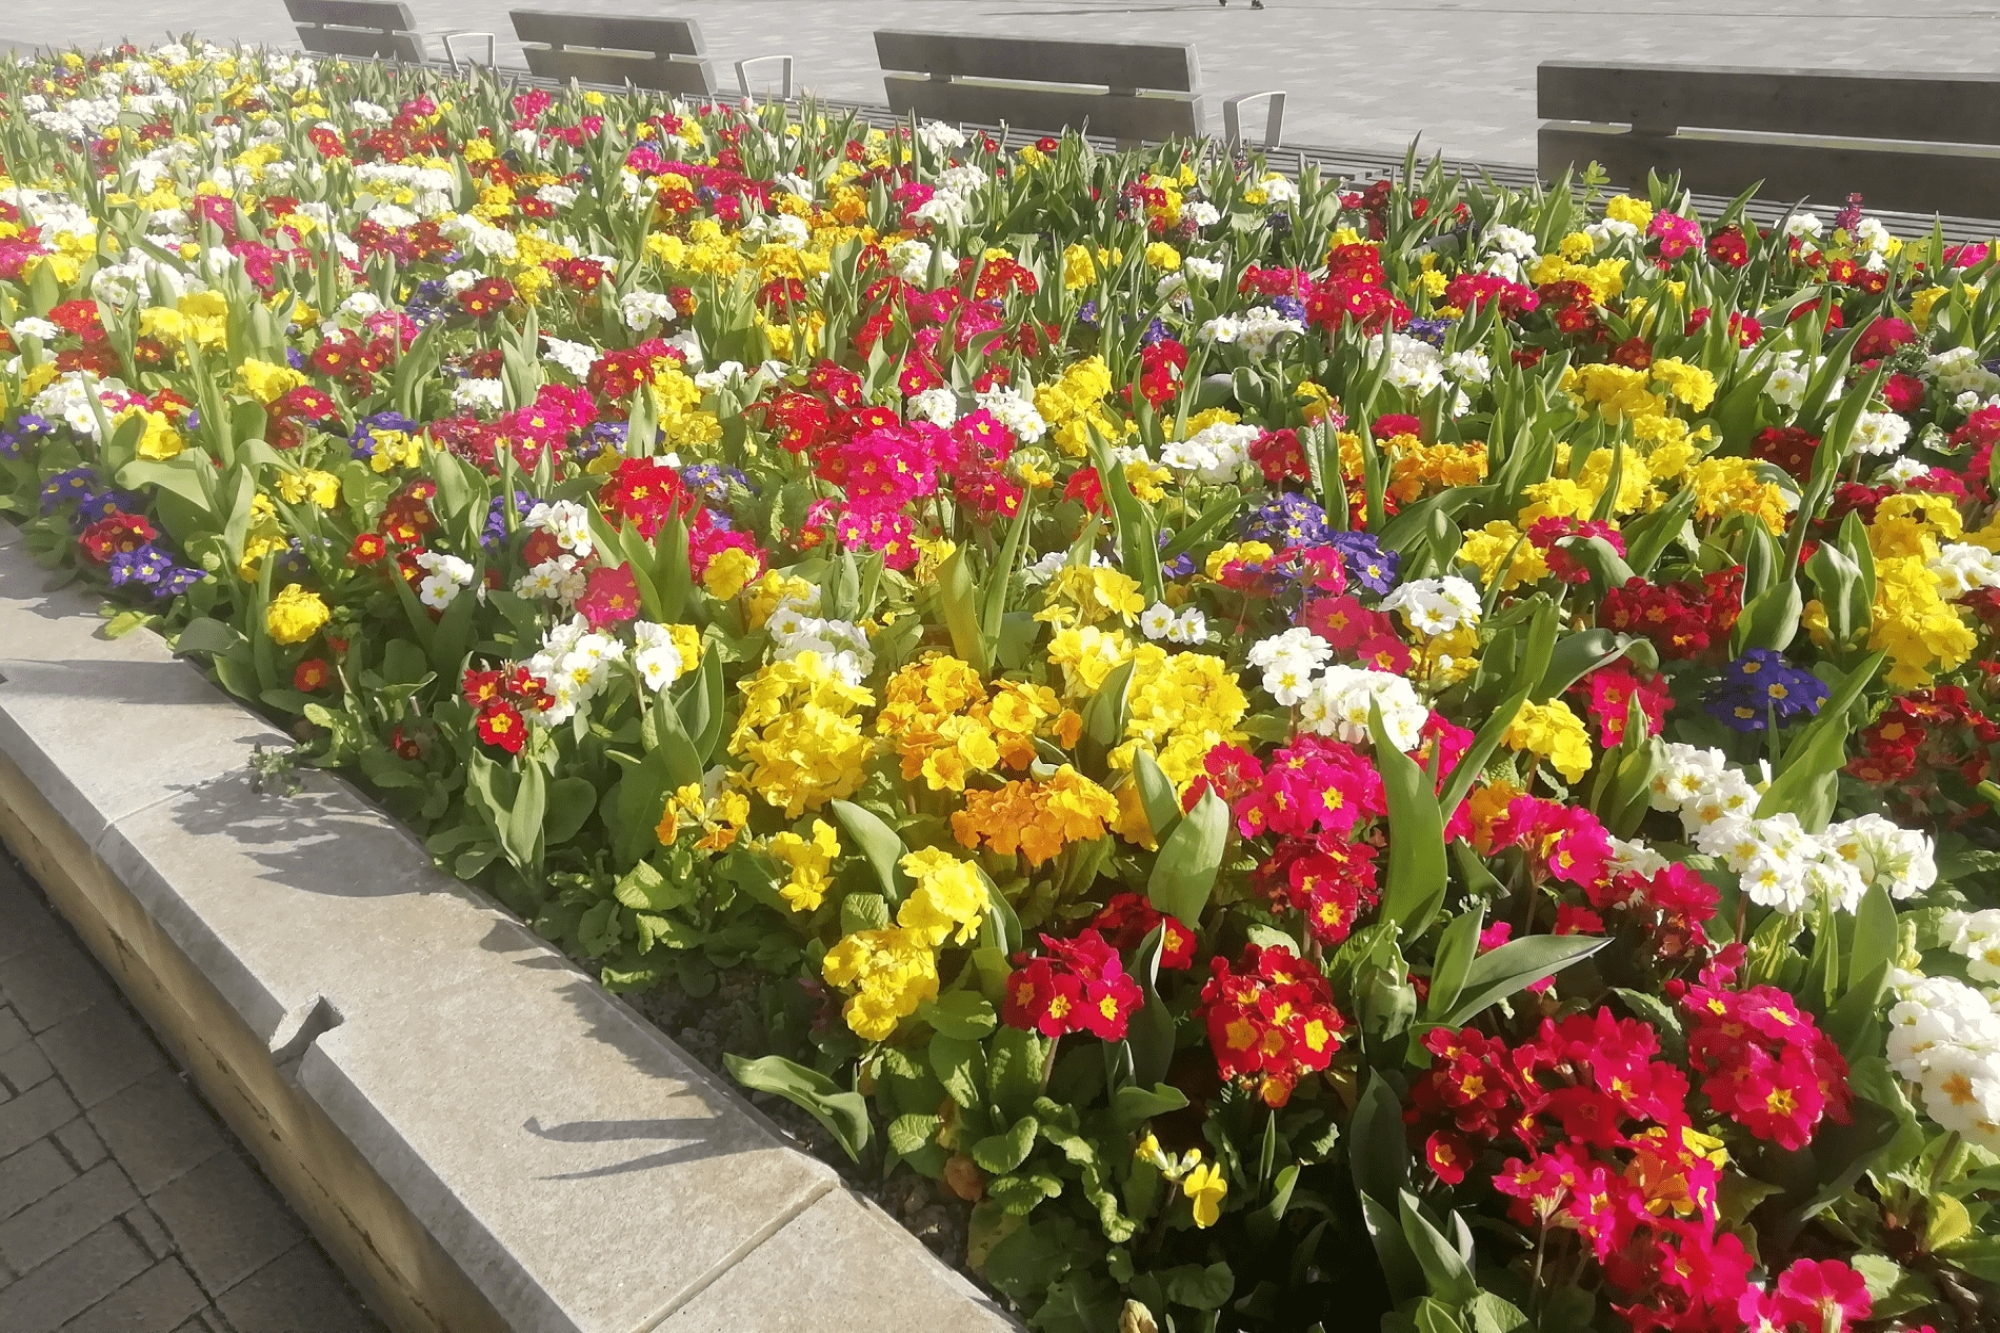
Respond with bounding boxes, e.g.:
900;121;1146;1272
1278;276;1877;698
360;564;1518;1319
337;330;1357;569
1536;60;2000;144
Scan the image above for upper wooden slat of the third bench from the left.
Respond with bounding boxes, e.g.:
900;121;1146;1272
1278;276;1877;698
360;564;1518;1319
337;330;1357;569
876;32;1202;92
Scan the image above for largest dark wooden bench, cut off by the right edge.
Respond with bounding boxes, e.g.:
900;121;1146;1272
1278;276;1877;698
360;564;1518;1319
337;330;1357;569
1536;60;2000;218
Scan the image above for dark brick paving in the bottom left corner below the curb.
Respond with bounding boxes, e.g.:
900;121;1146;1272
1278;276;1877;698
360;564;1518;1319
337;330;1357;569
0;851;382;1333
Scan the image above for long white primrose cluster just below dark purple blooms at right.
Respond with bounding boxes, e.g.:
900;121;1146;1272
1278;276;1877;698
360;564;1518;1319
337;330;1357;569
1652;743;1938;913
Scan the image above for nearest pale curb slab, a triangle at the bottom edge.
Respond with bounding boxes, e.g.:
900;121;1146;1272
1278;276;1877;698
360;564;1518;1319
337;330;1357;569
660;1189;1020;1333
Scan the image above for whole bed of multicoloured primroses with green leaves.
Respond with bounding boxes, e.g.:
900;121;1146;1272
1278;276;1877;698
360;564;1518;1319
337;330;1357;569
0;44;2000;1333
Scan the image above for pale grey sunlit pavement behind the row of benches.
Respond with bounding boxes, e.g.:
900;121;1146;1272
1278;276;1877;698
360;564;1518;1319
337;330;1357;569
11;0;2000;164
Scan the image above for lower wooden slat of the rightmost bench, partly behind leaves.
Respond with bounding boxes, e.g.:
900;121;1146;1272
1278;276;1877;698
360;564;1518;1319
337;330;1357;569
1536;124;2000;218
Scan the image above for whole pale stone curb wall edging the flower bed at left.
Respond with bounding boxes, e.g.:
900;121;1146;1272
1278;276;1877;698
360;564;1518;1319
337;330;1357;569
0;522;1018;1333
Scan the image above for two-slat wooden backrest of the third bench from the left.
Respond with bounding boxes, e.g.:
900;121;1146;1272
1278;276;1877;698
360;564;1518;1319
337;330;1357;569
876;32;1202;140
